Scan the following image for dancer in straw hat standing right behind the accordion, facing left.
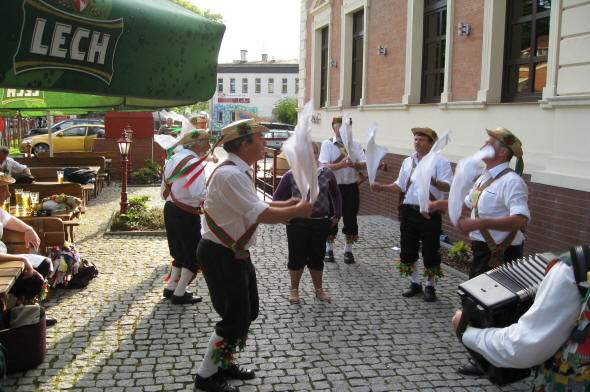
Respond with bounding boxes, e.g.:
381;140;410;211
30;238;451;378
429;127;531;375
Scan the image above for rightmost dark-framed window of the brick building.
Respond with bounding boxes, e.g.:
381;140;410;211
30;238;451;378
502;0;551;102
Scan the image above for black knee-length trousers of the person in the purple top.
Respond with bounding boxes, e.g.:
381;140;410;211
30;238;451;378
287;218;332;271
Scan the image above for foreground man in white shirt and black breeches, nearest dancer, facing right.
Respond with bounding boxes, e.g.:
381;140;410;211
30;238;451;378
195;119;312;392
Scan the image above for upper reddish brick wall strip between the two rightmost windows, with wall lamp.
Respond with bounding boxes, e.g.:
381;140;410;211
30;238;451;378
450;0;484;101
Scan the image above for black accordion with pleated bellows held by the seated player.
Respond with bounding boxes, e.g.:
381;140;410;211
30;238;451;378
457;253;559;385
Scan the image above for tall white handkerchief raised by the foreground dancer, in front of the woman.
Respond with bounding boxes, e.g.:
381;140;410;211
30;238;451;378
283;101;319;203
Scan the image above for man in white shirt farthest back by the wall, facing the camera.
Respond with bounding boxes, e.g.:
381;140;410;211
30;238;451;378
319;117;367;264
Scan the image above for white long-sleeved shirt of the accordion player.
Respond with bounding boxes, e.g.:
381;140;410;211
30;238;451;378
463;262;581;368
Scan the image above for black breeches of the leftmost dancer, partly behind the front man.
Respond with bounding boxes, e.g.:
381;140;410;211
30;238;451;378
164;201;201;274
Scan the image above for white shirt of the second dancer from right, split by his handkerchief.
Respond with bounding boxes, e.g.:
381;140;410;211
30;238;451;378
395;152;453;205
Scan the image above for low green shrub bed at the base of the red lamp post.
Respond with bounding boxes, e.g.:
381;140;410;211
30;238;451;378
111;196;165;231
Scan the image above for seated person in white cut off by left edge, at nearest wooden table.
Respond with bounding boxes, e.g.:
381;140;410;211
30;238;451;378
0;173;52;306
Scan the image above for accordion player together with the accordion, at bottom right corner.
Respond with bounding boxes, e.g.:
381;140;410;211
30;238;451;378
454;246;590;391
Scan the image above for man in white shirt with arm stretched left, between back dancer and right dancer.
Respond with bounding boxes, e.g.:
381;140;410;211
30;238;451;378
371;127;453;302
